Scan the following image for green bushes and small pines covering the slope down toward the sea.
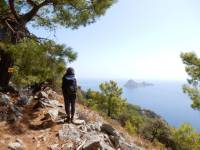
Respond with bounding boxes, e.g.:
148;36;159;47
79;81;200;150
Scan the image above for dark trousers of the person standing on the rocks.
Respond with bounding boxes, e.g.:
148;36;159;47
63;93;76;118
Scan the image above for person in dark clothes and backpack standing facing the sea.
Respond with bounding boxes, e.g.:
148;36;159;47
62;67;77;123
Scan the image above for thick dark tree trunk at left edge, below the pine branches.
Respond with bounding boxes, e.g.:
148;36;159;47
0;49;14;89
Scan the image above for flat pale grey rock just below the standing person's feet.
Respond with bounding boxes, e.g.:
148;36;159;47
58;124;80;142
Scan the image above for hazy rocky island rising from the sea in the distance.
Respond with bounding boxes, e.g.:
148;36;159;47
124;80;153;89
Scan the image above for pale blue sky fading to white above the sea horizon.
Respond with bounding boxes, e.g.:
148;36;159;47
31;0;200;80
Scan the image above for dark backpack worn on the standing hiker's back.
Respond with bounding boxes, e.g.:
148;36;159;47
63;76;77;95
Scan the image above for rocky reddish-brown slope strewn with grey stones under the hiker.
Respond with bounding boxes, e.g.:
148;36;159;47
0;87;143;150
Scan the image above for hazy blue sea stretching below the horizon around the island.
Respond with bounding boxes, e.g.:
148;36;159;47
78;79;200;131
